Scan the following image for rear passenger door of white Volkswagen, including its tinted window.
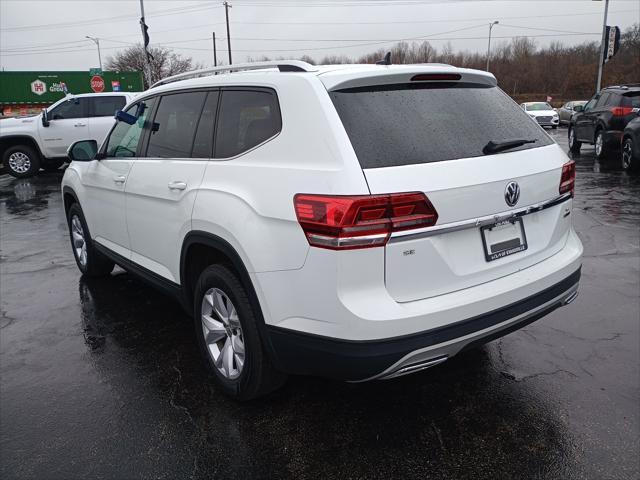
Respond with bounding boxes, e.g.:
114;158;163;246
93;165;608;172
126;90;219;283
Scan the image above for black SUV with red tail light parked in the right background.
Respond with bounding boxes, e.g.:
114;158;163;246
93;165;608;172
568;84;640;160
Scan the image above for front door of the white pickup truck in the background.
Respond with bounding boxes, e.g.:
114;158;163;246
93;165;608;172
39;97;91;158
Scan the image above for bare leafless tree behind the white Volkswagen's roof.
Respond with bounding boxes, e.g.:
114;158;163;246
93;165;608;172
105;45;202;88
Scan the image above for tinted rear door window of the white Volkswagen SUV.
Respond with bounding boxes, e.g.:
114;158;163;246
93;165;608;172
146;92;207;158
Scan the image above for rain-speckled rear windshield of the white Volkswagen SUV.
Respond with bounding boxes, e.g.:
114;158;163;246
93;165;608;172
330;83;553;168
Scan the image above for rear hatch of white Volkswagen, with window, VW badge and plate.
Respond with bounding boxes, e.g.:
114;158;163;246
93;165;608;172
330;76;571;302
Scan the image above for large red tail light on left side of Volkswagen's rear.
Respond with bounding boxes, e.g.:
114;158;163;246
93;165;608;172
293;192;438;250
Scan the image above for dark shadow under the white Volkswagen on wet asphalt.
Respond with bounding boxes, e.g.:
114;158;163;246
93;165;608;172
79;273;577;478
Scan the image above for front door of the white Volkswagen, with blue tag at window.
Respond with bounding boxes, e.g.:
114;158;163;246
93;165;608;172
82;99;154;259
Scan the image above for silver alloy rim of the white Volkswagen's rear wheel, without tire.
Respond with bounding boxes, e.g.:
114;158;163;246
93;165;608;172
201;288;245;380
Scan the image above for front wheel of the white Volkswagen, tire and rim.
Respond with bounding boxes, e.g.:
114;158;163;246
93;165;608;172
67;203;115;277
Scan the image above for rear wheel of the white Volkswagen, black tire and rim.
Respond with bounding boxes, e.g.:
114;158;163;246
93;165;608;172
193;265;286;400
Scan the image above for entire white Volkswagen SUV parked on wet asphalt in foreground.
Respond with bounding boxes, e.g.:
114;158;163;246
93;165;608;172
62;61;582;399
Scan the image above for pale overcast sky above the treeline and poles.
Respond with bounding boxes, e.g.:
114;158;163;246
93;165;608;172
0;0;640;70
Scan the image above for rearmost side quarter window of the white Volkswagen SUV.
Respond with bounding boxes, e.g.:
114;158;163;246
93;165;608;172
215;90;282;158
